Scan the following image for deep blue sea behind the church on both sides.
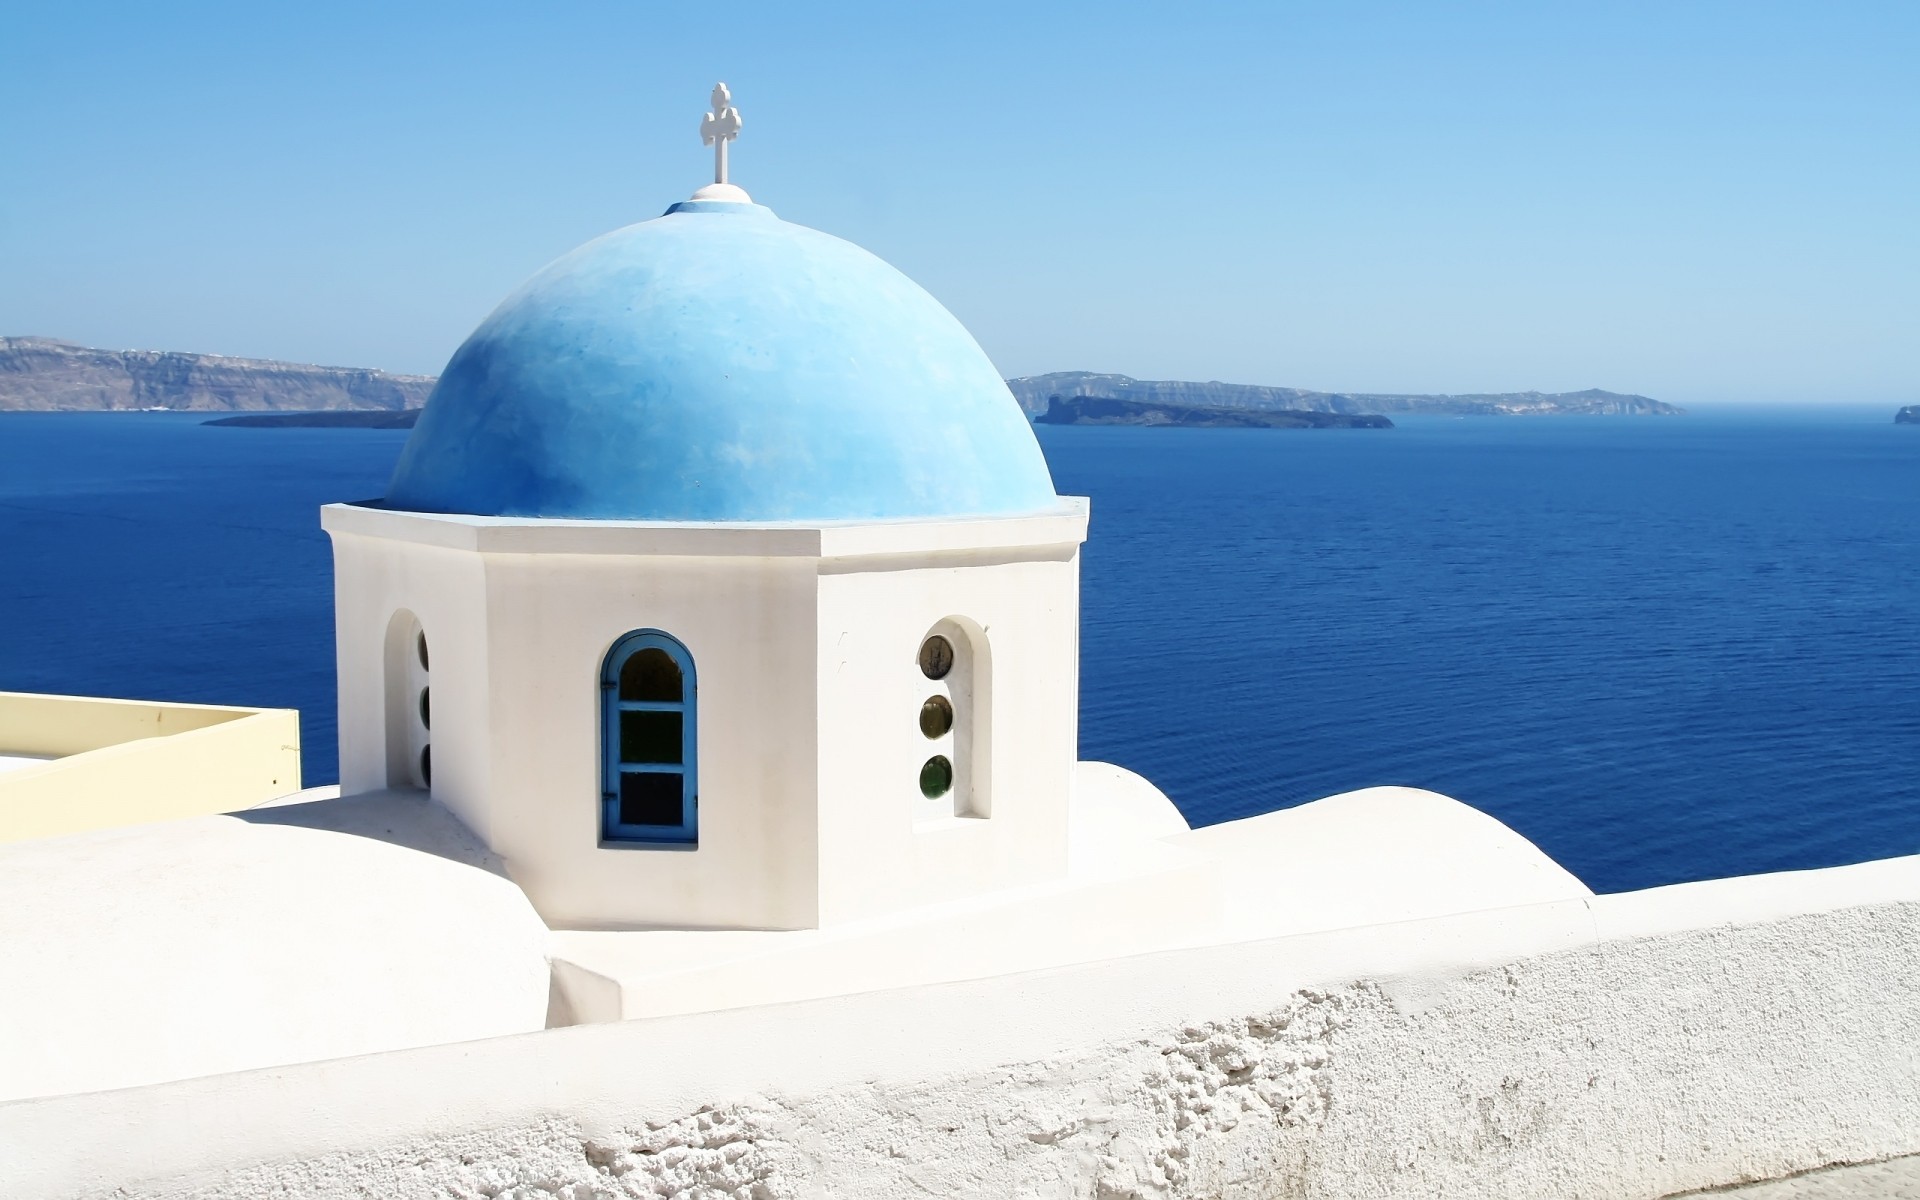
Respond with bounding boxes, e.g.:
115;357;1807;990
0;409;1920;891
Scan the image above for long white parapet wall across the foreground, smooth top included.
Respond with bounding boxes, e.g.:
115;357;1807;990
0;858;1920;1200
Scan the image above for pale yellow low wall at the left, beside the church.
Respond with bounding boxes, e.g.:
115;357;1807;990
0;691;300;841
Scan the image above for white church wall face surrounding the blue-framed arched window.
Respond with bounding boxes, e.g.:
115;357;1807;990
486;555;818;929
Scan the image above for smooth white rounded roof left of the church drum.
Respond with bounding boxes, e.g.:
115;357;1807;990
0;793;549;1098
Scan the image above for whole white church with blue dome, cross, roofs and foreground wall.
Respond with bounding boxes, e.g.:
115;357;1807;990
0;90;1920;1196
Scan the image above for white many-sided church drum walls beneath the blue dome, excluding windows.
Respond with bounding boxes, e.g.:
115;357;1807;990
323;501;1087;929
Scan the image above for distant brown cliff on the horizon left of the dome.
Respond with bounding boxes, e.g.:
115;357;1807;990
0;338;434;413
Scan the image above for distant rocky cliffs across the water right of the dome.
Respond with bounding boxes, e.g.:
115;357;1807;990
1006;371;1684;417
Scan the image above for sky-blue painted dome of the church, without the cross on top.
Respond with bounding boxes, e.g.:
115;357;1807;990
384;202;1058;522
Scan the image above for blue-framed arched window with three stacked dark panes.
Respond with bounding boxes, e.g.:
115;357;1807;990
601;630;701;843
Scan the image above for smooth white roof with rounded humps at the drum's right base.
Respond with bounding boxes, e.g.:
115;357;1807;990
553;783;1594;1021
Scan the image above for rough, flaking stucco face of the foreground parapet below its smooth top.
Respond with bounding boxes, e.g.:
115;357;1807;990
92;897;1920;1200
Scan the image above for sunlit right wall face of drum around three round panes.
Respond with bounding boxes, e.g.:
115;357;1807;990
818;540;1079;922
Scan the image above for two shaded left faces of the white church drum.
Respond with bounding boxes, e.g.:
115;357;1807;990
323;505;820;929
